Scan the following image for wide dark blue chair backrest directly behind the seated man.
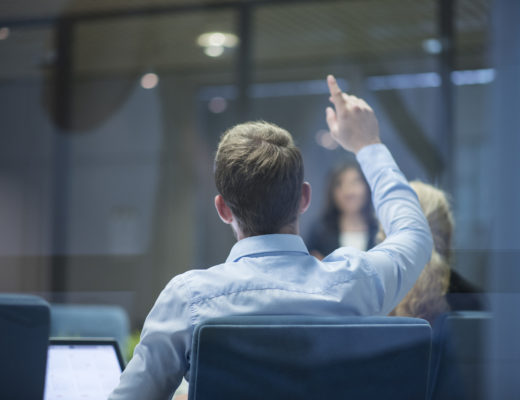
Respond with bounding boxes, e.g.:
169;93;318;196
188;316;431;400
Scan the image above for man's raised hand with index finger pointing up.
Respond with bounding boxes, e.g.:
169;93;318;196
326;75;381;153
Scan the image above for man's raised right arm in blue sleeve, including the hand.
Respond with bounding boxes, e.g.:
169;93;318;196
327;75;432;315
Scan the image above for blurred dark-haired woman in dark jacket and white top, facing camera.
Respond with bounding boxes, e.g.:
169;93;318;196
306;160;378;259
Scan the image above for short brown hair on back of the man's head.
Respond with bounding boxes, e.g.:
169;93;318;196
215;121;303;236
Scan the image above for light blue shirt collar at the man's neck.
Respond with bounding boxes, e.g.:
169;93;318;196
226;233;309;262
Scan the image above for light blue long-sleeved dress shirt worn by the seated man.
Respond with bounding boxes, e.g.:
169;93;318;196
110;144;432;400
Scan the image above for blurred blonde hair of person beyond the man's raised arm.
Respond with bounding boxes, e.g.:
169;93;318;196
390;181;454;323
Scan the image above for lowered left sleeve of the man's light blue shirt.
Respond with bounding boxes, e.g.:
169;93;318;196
109;275;193;400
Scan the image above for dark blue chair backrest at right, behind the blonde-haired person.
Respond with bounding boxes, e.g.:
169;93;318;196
430;311;491;400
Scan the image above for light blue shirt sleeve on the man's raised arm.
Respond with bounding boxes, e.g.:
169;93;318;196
357;144;433;315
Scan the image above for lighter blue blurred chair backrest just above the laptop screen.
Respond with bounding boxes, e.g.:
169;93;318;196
51;304;130;349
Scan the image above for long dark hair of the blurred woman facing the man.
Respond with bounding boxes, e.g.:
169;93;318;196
323;159;378;236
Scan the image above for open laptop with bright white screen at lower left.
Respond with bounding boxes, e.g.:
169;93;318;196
43;338;124;400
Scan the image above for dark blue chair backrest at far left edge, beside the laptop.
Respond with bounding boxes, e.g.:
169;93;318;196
0;294;49;400
